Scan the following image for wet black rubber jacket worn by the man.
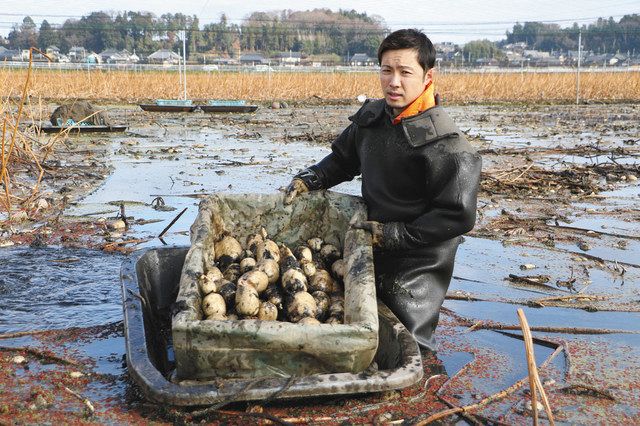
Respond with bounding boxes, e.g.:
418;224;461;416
310;99;481;250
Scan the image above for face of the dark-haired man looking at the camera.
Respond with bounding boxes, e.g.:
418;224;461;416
380;49;433;115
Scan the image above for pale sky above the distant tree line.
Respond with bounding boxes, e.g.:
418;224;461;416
0;0;640;44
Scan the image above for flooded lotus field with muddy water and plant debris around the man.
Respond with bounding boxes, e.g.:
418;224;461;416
0;103;640;424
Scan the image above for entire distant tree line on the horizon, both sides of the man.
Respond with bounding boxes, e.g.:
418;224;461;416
0;9;640;57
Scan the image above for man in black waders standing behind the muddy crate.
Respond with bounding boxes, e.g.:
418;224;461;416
285;29;481;350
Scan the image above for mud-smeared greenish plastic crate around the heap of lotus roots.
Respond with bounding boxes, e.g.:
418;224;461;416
172;191;378;379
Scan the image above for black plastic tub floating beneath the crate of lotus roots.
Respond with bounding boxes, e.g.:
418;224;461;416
120;247;423;406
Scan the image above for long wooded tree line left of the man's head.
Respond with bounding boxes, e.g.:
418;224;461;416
7;9;389;56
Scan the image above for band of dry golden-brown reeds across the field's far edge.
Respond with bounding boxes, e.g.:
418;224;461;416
0;69;640;104
